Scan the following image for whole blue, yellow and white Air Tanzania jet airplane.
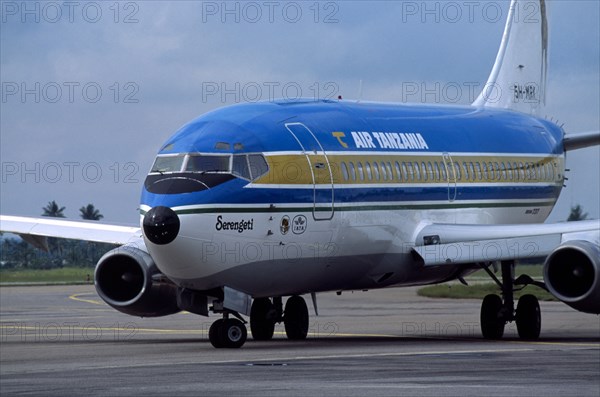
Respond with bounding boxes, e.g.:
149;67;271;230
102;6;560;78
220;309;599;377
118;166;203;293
0;0;600;348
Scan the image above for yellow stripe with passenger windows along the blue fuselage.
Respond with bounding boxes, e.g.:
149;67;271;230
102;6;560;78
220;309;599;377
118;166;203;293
254;152;564;185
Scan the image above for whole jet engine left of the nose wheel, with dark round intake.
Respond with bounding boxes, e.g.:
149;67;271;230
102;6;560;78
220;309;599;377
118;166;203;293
94;245;181;317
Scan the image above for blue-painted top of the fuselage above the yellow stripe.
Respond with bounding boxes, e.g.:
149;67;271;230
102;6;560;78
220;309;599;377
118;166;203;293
154;100;563;154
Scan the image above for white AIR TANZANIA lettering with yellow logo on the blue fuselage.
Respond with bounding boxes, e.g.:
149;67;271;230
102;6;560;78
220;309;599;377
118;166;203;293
331;131;429;150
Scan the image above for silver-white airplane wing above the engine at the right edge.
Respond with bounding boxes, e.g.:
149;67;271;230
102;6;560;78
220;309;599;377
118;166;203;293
414;219;600;266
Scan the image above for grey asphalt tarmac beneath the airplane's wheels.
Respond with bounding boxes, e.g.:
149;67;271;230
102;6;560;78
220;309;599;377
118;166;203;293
0;286;600;397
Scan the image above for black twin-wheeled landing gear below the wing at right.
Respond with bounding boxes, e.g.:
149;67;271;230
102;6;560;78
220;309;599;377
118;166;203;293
480;261;545;340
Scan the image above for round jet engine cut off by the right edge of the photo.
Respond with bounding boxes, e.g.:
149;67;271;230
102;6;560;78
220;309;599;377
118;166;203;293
544;240;600;314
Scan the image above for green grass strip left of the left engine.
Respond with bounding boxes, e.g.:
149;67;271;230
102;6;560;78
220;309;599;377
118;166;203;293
0;267;94;284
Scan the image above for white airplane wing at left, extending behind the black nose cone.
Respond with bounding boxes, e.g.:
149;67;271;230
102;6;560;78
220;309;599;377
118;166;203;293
0;215;142;251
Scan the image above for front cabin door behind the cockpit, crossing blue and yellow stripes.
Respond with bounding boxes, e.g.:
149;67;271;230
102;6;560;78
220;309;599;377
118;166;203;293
285;123;334;220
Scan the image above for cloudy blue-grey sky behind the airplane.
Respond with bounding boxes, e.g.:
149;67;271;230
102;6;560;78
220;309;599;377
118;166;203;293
0;0;600;224
